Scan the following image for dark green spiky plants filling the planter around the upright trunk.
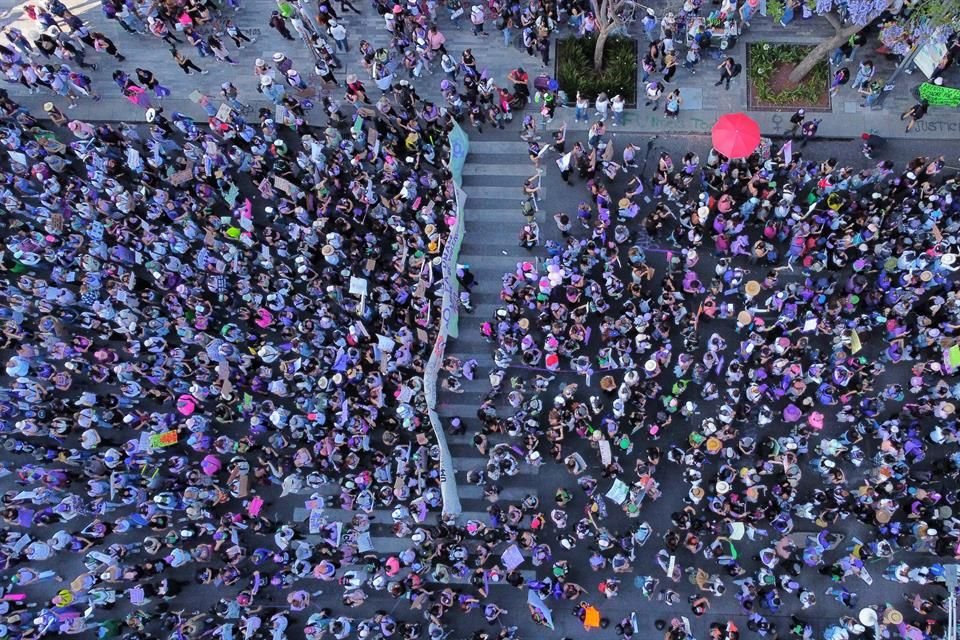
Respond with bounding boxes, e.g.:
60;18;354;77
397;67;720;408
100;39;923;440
557;36;637;106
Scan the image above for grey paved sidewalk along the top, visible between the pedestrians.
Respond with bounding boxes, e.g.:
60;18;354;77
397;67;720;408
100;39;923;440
0;0;960;140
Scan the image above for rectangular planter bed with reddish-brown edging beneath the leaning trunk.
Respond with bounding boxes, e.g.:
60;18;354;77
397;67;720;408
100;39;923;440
747;42;831;111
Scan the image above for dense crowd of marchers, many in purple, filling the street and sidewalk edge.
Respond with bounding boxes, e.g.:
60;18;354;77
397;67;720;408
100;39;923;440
0;0;960;640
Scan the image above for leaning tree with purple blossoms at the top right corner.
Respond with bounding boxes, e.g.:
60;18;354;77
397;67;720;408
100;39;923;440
790;0;960;83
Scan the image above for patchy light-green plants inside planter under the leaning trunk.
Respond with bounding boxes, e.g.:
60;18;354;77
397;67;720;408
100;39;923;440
747;42;830;106
